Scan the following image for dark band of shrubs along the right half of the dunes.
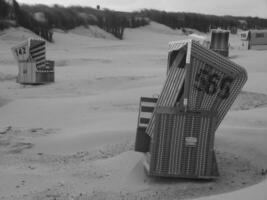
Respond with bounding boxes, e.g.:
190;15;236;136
136;9;267;32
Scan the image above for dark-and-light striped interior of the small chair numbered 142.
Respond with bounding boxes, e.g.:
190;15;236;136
30;40;46;71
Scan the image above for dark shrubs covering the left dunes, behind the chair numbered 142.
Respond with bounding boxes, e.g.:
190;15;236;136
0;0;148;41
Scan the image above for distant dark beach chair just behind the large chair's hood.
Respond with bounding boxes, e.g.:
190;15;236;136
210;29;230;57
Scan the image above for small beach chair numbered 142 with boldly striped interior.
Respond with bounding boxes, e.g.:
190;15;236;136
11;38;55;84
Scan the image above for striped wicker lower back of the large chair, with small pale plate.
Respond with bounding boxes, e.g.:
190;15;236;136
150;108;216;178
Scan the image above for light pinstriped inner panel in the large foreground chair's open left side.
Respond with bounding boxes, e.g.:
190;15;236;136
146;67;185;137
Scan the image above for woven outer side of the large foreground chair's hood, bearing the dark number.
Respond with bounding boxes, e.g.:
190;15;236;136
188;42;247;127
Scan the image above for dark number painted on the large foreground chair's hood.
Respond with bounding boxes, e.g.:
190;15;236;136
194;69;233;99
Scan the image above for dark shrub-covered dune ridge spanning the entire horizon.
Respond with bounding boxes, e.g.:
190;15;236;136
0;0;267;42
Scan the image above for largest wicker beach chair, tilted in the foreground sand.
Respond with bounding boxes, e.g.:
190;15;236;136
138;40;247;179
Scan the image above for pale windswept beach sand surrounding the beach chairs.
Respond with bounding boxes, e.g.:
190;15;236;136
0;22;267;200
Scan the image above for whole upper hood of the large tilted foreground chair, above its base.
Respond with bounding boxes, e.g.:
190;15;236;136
146;40;247;137
